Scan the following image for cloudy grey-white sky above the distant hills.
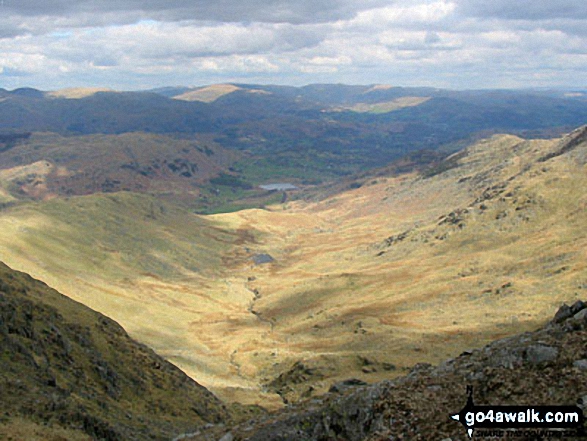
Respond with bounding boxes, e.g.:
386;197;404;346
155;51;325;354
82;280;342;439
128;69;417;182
0;0;587;90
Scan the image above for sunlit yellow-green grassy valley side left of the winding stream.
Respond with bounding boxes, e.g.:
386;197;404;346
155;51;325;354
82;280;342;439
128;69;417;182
0;193;284;402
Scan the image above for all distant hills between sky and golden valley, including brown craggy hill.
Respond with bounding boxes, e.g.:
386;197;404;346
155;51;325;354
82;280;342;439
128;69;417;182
0;84;587;212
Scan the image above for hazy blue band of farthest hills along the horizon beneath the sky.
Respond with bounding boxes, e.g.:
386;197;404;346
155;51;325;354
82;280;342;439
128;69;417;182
0;84;587;158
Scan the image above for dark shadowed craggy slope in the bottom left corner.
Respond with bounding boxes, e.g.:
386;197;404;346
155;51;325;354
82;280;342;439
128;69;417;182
0;263;229;440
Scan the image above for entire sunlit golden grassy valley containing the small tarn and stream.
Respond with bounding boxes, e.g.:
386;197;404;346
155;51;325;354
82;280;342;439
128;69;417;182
0;124;587;407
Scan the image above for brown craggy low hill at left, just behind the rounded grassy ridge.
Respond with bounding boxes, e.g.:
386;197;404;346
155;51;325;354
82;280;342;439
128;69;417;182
0;133;242;199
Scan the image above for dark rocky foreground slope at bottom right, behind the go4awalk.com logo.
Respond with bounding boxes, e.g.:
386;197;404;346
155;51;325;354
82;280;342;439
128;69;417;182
194;301;587;441
